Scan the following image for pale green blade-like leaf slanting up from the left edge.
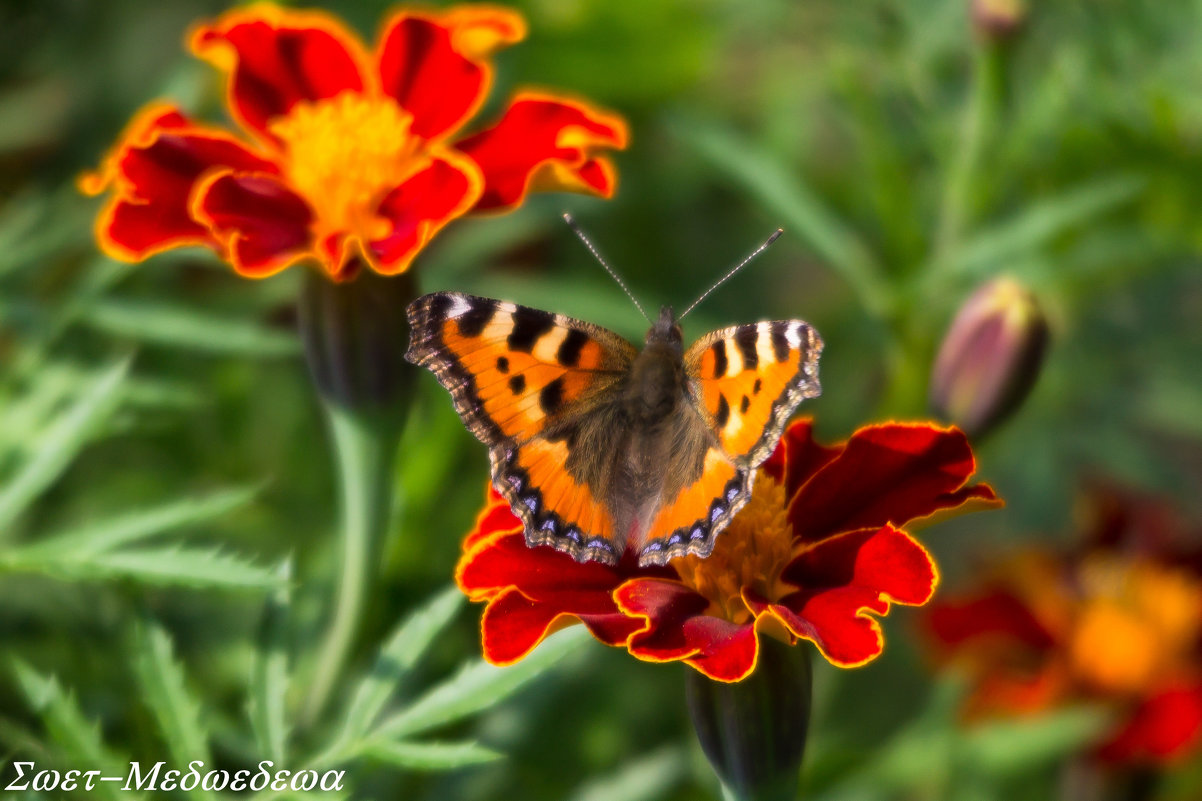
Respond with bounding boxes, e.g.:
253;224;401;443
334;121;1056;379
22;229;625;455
0;358;130;536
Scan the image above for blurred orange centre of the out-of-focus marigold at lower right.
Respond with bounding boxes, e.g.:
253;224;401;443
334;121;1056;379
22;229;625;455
1070;557;1202;693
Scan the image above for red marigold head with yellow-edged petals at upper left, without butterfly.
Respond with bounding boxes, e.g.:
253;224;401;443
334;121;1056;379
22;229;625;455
81;5;626;280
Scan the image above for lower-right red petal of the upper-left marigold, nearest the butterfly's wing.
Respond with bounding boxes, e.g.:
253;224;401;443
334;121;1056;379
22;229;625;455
367;150;483;275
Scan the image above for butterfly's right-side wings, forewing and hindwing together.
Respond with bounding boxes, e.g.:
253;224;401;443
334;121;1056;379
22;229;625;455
639;320;822;564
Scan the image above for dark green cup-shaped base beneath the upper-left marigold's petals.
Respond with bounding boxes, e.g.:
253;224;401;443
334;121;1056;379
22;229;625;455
299;260;417;419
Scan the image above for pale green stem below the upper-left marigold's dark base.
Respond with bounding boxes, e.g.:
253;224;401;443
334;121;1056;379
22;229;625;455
303;401;397;723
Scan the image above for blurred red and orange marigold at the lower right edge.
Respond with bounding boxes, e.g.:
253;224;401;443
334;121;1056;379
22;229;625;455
927;487;1202;764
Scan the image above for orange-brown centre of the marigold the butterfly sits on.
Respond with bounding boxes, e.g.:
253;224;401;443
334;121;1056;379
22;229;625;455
672;471;793;624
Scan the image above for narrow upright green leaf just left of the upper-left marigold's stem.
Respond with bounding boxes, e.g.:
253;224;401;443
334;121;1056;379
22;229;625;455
246;558;292;765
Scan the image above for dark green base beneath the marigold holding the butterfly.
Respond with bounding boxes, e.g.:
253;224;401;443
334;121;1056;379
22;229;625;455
685;636;811;801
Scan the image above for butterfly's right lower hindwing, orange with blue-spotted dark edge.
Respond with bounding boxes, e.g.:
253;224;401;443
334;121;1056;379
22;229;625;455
638;447;755;565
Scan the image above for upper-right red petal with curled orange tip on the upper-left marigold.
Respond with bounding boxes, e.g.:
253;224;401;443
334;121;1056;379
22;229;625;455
377;6;525;140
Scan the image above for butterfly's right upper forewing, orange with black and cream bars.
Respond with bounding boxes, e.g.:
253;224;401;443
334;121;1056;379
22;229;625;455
684;320;822;468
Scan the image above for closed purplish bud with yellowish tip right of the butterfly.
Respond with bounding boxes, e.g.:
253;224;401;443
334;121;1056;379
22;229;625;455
930;278;1048;437
